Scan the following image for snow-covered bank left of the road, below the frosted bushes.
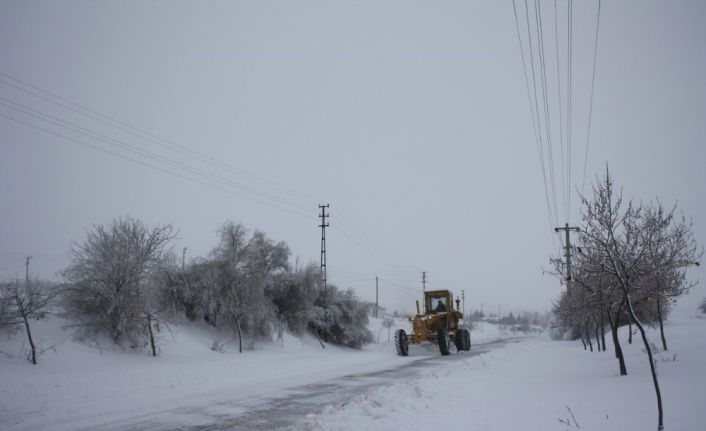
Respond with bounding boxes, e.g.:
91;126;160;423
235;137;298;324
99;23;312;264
0;317;497;430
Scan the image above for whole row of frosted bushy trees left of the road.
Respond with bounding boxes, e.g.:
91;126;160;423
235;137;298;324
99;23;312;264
0;217;373;362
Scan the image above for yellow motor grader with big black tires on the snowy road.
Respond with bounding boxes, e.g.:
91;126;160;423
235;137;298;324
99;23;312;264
395;290;471;356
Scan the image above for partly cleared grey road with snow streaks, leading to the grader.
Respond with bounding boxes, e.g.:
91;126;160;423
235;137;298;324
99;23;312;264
104;340;507;431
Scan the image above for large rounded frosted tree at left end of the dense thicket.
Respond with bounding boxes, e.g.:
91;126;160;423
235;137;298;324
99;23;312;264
63;217;176;354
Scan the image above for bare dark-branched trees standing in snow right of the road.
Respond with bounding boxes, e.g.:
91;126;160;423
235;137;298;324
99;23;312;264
552;169;703;429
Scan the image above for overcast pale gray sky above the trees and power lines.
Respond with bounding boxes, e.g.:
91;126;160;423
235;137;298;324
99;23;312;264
0;0;706;316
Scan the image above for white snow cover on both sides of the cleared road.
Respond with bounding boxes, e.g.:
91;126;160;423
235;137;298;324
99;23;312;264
0;317;706;430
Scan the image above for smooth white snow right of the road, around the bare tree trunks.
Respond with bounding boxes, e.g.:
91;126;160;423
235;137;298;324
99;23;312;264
305;316;706;431
